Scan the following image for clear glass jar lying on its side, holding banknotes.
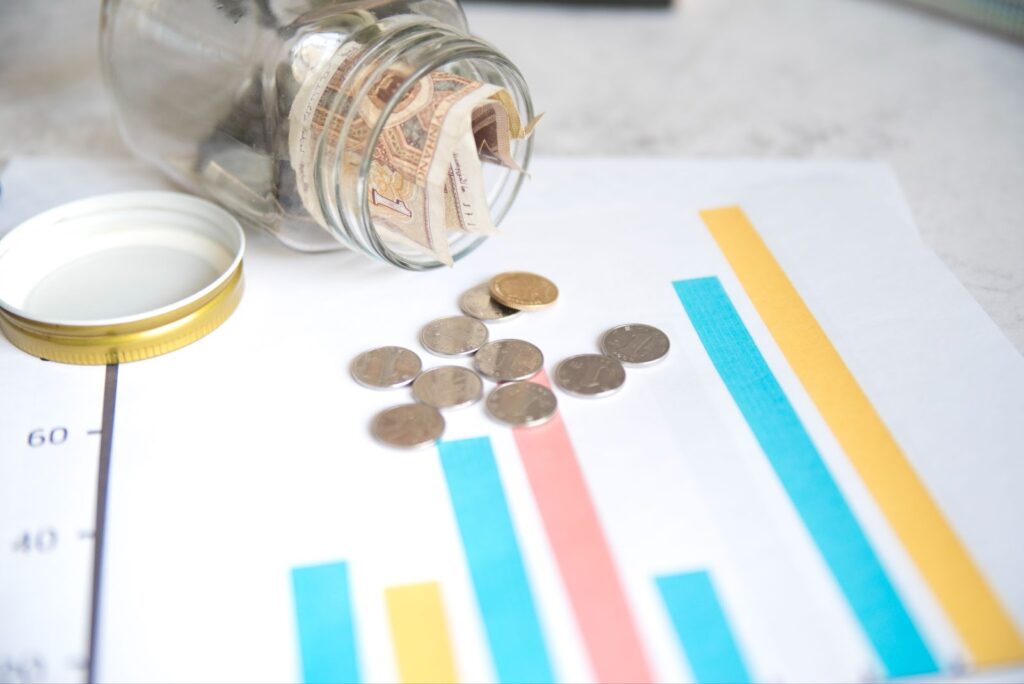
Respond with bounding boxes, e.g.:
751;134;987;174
100;0;534;269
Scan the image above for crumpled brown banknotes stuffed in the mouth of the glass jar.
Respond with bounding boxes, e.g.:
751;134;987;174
289;50;536;265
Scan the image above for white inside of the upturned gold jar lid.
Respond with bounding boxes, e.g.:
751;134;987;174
0;193;245;326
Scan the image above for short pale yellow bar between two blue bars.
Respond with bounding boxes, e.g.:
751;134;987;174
384;582;459;684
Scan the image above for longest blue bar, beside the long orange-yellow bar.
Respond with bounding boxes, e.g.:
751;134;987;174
673;277;938;677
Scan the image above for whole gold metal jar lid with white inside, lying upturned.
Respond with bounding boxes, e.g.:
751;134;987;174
0;193;245;365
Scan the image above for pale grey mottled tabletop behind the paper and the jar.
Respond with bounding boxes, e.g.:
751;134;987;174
0;0;1024;350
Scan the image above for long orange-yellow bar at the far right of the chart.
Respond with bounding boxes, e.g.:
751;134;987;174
700;207;1024;666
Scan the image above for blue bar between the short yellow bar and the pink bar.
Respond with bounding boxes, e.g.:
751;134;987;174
438;437;554;683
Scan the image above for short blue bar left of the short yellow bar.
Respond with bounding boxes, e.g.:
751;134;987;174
292;563;359;684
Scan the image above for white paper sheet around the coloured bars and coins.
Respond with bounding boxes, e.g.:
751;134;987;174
0;159;1024;681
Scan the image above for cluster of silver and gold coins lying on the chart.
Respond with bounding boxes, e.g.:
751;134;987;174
351;271;669;447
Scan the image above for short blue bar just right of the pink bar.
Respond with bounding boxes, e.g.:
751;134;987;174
655;570;751;684
